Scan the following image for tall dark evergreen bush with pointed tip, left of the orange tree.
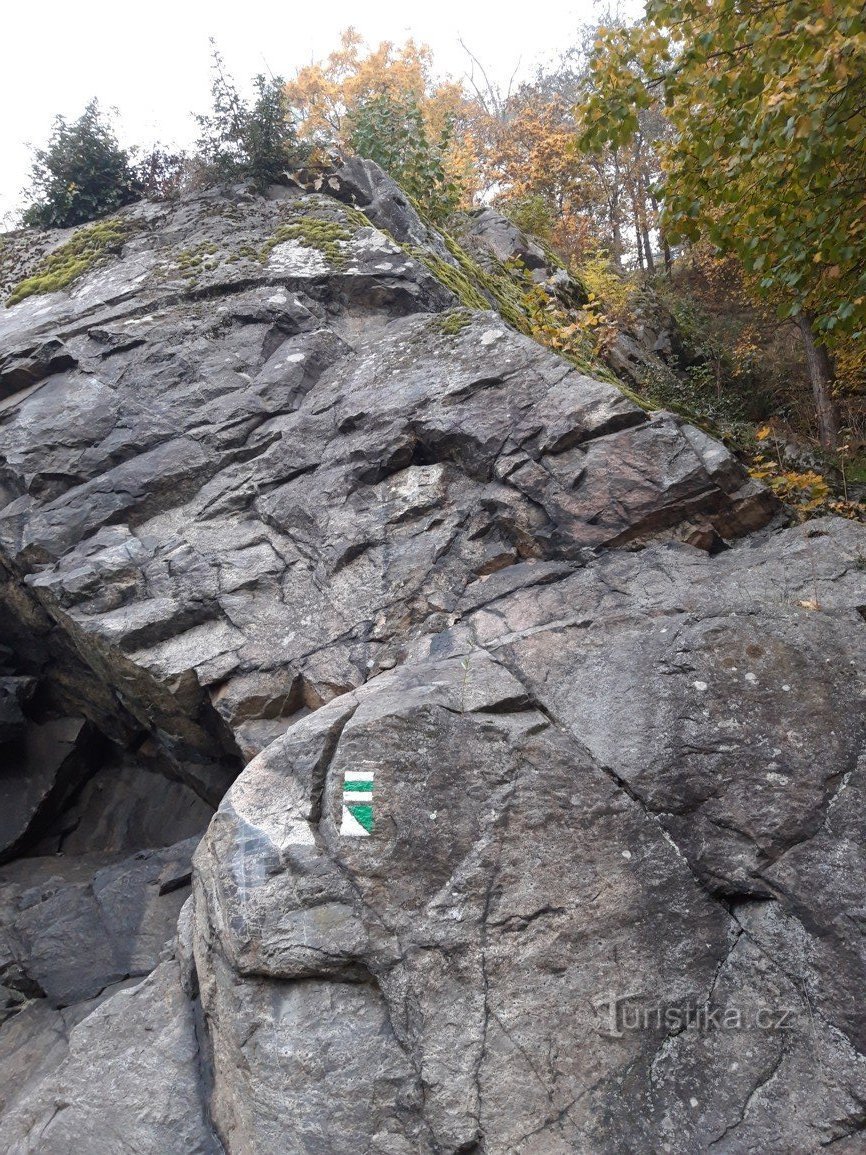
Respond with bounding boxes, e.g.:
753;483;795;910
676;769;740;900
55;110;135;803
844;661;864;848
195;49;309;192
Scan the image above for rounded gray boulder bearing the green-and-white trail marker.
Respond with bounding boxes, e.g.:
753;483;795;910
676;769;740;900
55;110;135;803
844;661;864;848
193;521;866;1155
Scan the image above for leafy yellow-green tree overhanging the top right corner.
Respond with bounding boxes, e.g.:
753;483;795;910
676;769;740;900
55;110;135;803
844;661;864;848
582;0;866;447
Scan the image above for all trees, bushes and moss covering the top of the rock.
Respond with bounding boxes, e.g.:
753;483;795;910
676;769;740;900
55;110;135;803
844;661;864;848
11;21;866;508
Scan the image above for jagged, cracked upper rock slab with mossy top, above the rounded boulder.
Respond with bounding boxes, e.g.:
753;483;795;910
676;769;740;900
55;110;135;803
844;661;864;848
0;184;774;776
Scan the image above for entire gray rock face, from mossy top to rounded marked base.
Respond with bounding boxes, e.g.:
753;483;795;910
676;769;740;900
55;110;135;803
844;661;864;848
0;163;866;1155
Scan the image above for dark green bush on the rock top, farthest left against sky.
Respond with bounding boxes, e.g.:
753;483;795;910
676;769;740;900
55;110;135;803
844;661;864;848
23;100;141;229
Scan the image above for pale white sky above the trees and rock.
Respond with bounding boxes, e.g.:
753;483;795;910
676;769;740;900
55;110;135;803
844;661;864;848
0;0;641;226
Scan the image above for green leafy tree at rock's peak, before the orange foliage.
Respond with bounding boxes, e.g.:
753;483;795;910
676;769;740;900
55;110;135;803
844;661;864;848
348;92;461;222
